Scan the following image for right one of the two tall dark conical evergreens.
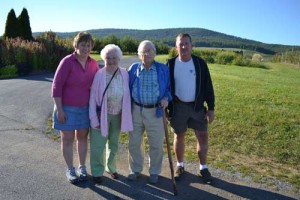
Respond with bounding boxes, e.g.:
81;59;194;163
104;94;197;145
18;8;33;40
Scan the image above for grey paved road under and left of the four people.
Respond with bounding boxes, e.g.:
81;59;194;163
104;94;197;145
0;58;299;200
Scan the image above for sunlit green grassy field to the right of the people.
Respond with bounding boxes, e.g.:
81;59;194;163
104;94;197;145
122;56;300;189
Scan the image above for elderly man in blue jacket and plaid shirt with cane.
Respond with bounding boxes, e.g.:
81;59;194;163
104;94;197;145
128;40;171;184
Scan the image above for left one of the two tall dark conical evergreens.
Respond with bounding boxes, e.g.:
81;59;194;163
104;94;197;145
3;9;21;38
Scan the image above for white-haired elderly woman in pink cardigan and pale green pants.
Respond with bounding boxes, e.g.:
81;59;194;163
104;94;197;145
89;44;133;183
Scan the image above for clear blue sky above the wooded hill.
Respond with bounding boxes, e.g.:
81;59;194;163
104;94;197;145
0;0;300;45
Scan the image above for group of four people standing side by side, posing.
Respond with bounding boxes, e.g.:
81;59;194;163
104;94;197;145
52;32;214;184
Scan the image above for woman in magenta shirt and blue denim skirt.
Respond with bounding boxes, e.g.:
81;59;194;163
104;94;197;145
52;32;99;184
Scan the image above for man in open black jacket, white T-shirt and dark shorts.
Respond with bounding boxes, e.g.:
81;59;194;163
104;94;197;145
167;33;215;183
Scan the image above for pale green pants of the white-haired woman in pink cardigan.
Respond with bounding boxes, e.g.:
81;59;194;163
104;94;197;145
90;115;121;177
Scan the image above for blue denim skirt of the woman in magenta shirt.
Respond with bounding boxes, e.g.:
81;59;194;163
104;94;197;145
52;106;90;131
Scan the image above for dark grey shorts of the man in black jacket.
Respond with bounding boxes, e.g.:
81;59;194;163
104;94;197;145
171;101;207;134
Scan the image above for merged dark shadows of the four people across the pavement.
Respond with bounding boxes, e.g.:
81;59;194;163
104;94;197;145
72;171;294;200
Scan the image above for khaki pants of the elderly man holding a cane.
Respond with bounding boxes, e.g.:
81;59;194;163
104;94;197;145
128;105;164;174
